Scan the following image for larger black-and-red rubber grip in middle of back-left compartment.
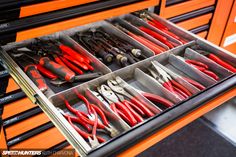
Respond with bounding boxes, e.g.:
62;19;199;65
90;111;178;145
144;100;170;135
39;57;75;82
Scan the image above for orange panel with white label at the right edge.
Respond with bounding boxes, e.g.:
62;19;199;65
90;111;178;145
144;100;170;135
220;1;236;54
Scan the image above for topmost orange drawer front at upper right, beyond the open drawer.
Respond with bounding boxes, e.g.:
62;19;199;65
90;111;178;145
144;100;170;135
160;0;216;18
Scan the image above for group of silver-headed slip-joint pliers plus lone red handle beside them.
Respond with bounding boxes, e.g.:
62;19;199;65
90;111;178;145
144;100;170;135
97;77;173;127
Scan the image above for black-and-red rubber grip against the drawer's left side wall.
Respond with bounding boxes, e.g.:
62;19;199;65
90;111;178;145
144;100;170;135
24;65;48;92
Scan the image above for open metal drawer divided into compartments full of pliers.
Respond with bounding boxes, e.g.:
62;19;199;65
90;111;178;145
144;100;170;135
0;10;236;156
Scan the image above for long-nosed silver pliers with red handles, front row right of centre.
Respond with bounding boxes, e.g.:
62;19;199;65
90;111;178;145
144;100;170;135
148;62;192;100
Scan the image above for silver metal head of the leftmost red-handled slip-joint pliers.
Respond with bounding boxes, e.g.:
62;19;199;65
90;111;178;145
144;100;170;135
97;84;119;104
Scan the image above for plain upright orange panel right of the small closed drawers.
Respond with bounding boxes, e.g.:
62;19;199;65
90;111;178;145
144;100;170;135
207;0;234;45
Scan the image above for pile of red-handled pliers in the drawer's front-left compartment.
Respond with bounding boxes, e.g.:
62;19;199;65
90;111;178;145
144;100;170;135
58;92;119;148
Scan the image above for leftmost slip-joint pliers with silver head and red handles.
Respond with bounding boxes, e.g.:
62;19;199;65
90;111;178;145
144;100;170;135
97;84;137;126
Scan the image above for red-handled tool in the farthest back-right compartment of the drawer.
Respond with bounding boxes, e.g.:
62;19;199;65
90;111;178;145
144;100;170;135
138;11;186;44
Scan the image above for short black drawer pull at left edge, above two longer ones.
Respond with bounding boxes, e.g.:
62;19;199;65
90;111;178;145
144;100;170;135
0;89;26;106
